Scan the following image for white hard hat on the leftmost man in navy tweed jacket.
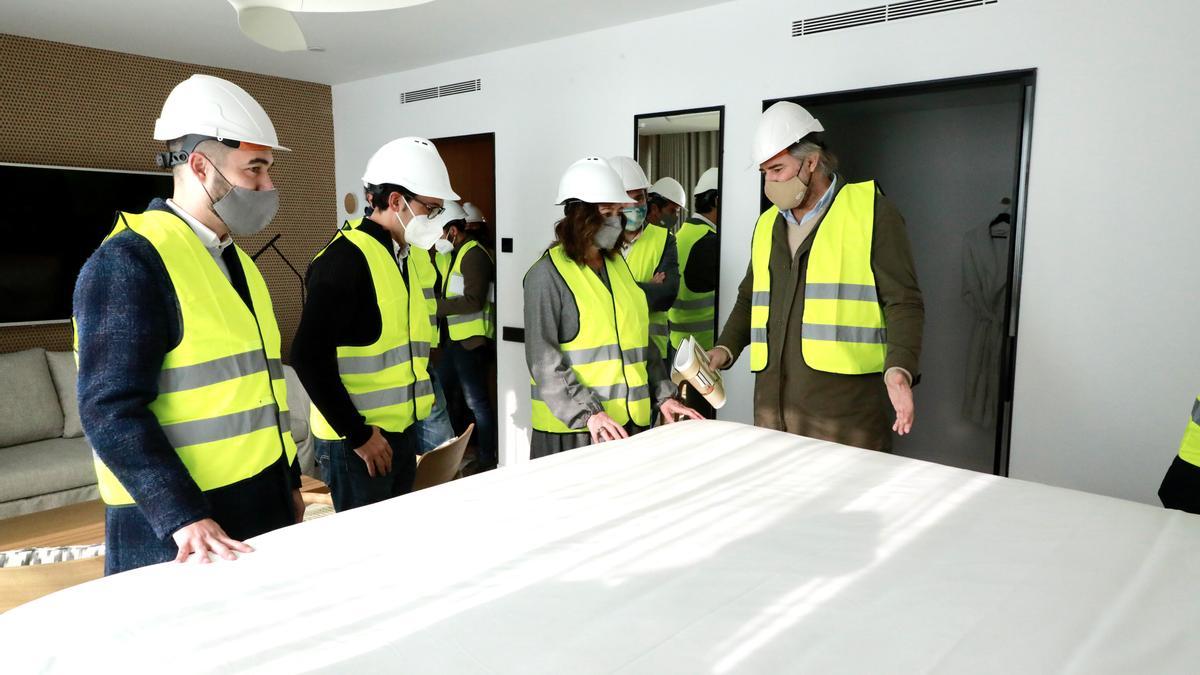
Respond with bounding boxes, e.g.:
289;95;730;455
154;74;287;150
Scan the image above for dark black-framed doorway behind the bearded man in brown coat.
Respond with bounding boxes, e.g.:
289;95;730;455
764;71;1036;476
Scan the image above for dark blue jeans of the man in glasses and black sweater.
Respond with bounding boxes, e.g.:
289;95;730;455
313;428;416;512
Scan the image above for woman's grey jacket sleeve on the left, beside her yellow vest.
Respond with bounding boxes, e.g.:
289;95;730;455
524;257;604;429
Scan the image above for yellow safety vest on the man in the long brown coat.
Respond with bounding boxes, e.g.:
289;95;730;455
750;181;888;375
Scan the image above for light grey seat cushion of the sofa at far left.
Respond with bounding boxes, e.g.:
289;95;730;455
0;438;96;502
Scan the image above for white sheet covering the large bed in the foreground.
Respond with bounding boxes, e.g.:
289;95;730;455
0;422;1200;675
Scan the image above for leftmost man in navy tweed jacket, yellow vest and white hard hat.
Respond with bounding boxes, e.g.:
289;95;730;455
74;74;304;574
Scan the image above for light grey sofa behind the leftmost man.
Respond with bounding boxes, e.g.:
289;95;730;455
0;348;316;519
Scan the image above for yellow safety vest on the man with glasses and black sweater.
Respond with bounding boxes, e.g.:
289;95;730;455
310;227;433;441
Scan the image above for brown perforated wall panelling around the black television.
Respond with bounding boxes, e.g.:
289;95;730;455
0;34;338;359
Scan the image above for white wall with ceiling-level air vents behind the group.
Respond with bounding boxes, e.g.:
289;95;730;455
334;0;1200;501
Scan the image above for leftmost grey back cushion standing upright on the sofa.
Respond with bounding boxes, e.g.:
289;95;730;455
0;348;62;448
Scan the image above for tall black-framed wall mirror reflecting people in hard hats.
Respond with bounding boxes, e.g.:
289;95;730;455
626;107;725;418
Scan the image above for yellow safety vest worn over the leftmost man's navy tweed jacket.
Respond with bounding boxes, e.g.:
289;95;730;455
82;211;296;506
